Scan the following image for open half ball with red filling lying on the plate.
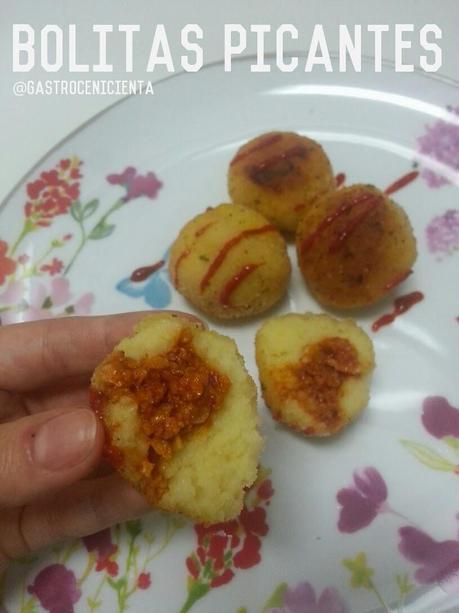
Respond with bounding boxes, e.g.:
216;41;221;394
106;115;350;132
255;313;374;436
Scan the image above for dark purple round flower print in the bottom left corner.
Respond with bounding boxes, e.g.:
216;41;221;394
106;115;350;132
27;564;81;613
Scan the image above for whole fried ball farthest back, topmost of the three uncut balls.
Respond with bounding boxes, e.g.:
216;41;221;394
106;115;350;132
228;132;336;233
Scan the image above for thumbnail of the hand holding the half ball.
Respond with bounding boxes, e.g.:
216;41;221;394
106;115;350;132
32;409;97;470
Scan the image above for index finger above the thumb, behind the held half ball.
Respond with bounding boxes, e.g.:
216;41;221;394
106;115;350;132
0;311;203;392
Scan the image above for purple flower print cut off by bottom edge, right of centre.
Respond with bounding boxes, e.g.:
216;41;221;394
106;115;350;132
268;582;346;613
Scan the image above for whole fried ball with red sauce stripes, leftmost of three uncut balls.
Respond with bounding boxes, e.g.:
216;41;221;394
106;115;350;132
169;204;291;319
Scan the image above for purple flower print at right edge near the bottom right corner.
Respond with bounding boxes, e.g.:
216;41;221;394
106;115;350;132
398;526;459;591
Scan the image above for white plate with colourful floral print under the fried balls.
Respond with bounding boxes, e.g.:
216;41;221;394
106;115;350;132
0;60;459;613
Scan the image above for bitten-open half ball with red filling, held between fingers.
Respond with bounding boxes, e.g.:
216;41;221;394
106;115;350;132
91;314;262;524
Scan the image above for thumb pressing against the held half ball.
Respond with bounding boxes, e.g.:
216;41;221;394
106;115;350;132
0;409;103;507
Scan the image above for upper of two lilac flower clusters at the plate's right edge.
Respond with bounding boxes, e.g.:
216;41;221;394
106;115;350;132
418;107;459;187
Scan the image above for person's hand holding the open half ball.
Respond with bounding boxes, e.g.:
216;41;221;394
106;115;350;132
0;313;199;572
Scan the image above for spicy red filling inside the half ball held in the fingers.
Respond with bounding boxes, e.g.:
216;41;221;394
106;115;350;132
91;330;230;493
